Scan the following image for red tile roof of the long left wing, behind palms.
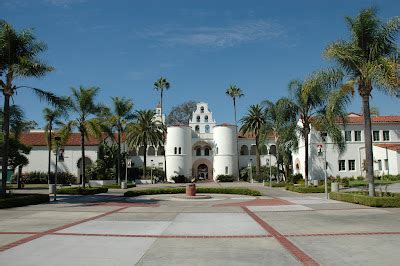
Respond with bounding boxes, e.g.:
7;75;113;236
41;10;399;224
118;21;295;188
20;132;115;146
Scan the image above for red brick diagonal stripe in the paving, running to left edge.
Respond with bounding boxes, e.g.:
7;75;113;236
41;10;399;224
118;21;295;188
0;207;128;252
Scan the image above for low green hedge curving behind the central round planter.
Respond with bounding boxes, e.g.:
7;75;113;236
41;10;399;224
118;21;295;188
124;187;261;197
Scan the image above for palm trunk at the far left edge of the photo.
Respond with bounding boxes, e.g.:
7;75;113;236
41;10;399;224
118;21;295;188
1;93;10;197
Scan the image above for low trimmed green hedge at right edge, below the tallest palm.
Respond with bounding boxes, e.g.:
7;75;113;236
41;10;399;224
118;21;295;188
329;192;400;207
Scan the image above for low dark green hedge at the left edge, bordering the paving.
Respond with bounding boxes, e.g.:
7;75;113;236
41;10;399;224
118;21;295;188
0;194;49;209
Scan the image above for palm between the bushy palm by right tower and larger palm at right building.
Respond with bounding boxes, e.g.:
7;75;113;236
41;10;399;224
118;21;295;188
261;98;296;179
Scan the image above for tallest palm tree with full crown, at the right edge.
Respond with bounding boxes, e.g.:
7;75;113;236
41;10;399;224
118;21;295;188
325;8;400;196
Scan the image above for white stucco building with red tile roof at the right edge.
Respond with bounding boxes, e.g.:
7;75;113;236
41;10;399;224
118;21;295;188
292;113;400;179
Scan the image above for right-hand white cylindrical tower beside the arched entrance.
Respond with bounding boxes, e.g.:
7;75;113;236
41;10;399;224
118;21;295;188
213;124;239;180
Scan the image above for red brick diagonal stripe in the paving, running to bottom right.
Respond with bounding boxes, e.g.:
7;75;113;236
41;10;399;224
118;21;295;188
242;207;319;265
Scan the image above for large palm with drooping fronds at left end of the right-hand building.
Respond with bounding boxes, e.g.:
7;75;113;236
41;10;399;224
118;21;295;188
288;70;352;186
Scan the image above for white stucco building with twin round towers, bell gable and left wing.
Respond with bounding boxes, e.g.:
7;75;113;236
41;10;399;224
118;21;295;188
21;102;276;181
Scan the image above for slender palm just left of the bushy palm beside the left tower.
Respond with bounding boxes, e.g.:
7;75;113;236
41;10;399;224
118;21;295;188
107;97;134;184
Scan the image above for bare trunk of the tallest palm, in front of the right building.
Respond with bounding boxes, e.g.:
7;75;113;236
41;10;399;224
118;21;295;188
362;94;375;197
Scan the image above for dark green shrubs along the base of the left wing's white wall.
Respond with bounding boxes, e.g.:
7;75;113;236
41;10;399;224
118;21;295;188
21;171;76;185
